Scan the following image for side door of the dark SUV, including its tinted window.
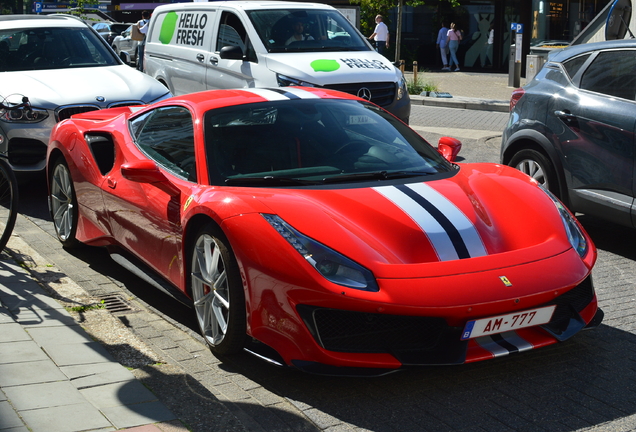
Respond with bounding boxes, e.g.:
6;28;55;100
548;50;636;225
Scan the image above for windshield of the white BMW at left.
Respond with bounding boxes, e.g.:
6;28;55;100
0;27;119;72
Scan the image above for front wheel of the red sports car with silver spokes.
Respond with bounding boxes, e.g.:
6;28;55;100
189;223;247;355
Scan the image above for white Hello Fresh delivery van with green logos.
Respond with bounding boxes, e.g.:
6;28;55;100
144;1;411;122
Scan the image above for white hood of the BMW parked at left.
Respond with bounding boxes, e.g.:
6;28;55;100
0;65;168;109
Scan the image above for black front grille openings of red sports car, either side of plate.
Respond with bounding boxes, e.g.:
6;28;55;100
297;277;594;365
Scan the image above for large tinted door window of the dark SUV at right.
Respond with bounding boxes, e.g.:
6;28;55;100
581;50;636;100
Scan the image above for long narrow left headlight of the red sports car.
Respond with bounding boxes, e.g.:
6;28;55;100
262;214;380;292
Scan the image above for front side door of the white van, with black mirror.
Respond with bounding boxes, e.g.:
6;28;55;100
207;11;258;89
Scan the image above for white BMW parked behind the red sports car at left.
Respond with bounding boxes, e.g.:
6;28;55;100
0;15;170;171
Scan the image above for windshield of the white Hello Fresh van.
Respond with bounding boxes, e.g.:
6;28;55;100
247;9;372;53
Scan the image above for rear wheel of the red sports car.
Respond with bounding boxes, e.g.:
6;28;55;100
49;157;81;248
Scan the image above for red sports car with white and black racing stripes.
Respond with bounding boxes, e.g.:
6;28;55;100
47;88;602;374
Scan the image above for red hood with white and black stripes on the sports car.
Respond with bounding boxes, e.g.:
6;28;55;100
250;164;571;265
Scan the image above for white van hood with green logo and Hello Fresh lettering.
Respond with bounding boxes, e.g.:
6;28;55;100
267;51;401;86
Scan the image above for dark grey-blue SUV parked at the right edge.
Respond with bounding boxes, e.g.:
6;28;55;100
501;40;636;227
